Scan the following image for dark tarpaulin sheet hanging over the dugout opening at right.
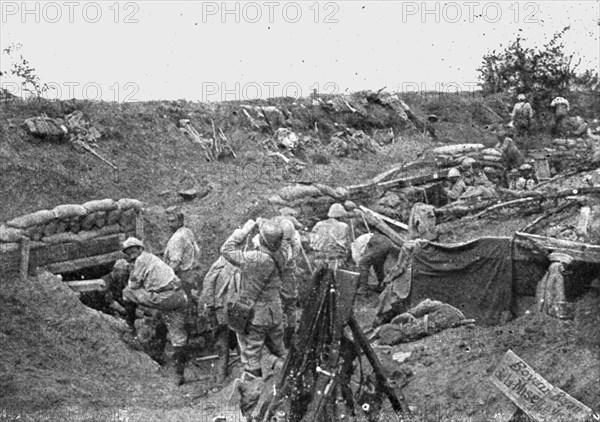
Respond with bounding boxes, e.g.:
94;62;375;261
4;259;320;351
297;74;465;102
411;237;512;325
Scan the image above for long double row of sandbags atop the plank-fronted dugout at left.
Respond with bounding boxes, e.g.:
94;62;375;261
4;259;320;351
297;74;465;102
0;198;142;244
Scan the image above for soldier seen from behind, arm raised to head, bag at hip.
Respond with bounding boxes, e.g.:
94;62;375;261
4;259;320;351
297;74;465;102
221;220;285;418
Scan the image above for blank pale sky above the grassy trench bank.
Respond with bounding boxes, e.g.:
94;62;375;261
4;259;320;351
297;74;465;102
0;0;600;102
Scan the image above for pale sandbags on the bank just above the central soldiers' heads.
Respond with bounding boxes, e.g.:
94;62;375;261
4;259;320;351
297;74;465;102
268;183;349;224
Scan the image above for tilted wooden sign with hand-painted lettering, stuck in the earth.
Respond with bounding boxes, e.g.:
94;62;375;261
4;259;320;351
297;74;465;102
490;350;593;422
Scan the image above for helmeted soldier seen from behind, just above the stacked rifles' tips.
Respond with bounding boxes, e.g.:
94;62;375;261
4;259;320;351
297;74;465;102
310;203;350;270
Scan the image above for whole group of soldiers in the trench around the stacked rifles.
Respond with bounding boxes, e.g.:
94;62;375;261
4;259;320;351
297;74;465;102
89;202;399;417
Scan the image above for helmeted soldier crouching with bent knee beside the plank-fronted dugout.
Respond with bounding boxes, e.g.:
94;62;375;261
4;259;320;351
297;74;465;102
123;237;189;385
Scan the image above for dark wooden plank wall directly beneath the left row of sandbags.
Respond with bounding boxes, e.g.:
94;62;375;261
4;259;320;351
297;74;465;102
31;233;125;267
